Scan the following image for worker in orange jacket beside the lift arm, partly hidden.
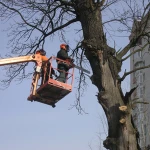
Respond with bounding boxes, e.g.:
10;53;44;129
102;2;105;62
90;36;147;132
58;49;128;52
36;49;56;84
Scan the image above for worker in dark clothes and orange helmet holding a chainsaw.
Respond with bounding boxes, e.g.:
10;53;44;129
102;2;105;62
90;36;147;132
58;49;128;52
57;44;73;83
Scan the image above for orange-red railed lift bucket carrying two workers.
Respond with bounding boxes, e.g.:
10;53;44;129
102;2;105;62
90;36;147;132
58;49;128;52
28;57;74;107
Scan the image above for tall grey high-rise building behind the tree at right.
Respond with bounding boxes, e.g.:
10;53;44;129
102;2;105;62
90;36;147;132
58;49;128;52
129;13;150;148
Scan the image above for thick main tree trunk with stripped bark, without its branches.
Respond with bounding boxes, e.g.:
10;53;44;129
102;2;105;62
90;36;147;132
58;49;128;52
76;0;137;150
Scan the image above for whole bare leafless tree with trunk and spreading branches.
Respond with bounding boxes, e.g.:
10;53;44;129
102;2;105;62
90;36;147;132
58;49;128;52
0;0;150;150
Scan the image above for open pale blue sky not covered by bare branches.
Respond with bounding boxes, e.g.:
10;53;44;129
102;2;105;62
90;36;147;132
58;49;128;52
0;8;129;150
